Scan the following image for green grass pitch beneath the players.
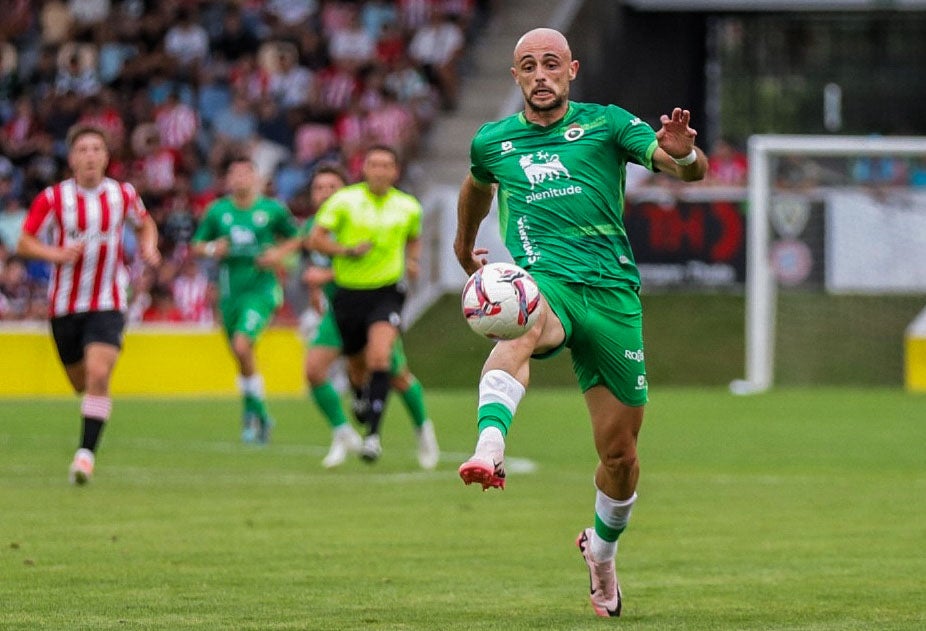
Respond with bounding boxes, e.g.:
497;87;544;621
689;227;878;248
0;387;926;631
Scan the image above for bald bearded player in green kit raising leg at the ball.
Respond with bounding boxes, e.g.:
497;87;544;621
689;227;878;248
454;28;707;616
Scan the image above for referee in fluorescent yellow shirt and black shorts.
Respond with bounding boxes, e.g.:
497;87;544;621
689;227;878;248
309;145;421;462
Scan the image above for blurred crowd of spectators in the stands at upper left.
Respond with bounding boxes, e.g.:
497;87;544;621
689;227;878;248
0;0;491;324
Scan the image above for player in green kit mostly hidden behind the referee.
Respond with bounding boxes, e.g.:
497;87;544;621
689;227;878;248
300;164;440;469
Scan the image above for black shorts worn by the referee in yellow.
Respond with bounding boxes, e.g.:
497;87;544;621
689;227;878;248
332;285;405;355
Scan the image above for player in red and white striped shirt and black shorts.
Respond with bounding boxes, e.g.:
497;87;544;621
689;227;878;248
16;125;161;484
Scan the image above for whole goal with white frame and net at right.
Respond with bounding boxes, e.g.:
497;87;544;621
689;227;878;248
731;135;926;393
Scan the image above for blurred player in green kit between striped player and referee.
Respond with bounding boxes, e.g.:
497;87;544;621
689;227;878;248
192;156;299;444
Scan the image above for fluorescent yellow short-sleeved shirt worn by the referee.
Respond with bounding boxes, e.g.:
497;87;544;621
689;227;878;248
315;182;421;289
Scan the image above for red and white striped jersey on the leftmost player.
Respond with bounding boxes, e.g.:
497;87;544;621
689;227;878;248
23;178;148;317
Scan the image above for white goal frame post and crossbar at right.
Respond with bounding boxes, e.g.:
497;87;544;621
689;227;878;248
730;134;926;394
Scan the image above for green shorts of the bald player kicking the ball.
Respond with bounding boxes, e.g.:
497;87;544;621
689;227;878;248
534;275;647;406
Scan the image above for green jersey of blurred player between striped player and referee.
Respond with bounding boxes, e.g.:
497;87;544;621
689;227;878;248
193;196;298;300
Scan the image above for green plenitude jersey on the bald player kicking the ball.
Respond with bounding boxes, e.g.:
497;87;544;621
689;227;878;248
470;102;657;287
